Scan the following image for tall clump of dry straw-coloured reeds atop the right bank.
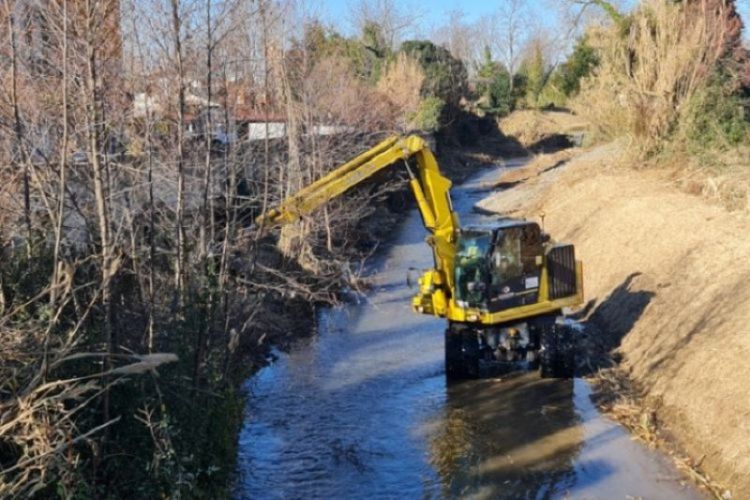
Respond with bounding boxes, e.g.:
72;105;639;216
573;0;727;154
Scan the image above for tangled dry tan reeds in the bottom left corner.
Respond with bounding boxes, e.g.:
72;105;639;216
0;338;177;498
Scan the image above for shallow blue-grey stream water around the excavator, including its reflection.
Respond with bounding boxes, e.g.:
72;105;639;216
235;162;701;499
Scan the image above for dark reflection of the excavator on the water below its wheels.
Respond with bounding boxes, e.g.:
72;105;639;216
428;373;592;498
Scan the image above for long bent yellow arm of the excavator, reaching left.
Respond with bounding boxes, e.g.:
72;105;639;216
256;135;460;316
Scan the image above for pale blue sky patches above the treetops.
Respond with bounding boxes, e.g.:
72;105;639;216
319;0;750;39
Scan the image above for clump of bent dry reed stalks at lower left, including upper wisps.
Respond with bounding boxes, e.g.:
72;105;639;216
0;278;177;498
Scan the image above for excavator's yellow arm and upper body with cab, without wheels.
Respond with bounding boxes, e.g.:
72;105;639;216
256;135;583;338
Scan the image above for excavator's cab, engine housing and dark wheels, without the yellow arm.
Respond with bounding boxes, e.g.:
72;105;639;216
445;220;582;379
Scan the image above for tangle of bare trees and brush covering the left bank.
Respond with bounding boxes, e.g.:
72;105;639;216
0;0;418;497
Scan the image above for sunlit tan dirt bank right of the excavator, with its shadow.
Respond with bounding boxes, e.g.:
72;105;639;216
479;140;750;498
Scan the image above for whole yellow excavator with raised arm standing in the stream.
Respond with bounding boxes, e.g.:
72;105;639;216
256;135;583;379
